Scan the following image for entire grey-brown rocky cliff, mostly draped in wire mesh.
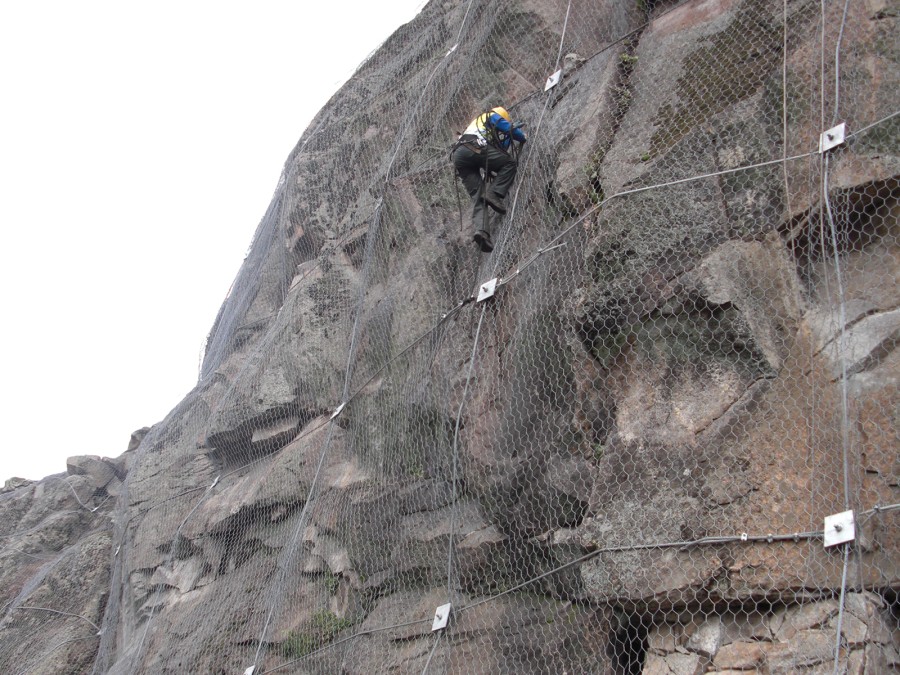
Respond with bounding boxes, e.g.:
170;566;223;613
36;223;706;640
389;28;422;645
0;0;900;675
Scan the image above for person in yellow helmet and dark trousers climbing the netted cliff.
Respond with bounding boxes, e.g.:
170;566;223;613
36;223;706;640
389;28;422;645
450;106;525;253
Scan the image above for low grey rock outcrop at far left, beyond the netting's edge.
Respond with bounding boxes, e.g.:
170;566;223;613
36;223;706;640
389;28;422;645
0;468;124;673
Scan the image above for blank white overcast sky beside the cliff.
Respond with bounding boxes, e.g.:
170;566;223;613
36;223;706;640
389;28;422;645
0;0;425;482
